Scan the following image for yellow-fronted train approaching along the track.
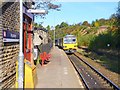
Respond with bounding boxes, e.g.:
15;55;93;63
55;35;78;53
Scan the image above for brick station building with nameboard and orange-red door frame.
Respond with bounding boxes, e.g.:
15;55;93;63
0;0;33;89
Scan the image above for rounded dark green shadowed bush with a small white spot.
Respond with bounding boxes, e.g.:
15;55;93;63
89;32;115;50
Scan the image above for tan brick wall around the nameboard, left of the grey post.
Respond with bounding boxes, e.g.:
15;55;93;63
0;2;19;89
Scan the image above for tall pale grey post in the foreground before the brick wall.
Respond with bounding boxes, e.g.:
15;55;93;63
18;0;24;89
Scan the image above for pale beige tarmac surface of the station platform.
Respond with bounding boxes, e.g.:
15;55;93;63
35;47;84;88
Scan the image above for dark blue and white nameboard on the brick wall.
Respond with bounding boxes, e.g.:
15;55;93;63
3;30;19;42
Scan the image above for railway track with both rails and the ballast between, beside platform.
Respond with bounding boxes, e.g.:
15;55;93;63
68;54;120;90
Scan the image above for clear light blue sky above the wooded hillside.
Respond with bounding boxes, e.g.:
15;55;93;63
35;2;118;27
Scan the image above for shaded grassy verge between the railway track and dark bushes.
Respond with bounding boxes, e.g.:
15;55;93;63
78;49;120;74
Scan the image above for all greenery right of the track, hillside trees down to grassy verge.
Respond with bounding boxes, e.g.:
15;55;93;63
46;2;120;73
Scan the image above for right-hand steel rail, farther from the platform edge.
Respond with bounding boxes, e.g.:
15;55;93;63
74;54;120;90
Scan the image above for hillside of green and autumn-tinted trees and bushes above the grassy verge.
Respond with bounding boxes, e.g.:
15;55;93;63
49;2;120;50
